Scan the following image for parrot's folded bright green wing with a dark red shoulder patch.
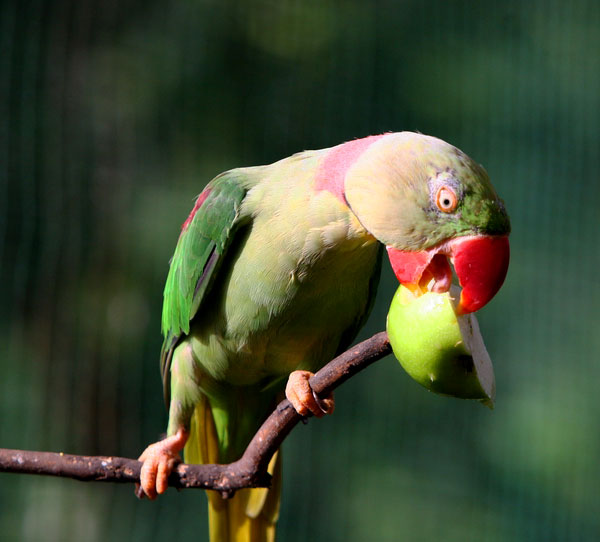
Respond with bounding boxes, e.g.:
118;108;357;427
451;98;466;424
160;170;247;406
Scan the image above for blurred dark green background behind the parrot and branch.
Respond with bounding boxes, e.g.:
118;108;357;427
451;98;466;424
0;0;600;542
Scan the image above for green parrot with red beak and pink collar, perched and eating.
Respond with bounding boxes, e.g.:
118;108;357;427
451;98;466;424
138;132;510;542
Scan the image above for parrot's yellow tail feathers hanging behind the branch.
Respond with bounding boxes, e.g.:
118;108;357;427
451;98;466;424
184;397;281;542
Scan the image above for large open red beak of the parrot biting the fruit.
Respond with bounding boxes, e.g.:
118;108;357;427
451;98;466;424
387;235;510;314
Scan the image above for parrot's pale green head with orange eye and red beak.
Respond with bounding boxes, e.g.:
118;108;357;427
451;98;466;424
344;132;510;313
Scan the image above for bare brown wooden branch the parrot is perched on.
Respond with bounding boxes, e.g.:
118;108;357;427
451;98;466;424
0;332;391;497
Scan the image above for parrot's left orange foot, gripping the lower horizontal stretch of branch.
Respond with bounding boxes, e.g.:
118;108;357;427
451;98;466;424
136;427;189;500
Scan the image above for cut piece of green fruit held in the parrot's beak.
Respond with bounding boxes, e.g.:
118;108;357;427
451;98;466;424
387;286;496;407
